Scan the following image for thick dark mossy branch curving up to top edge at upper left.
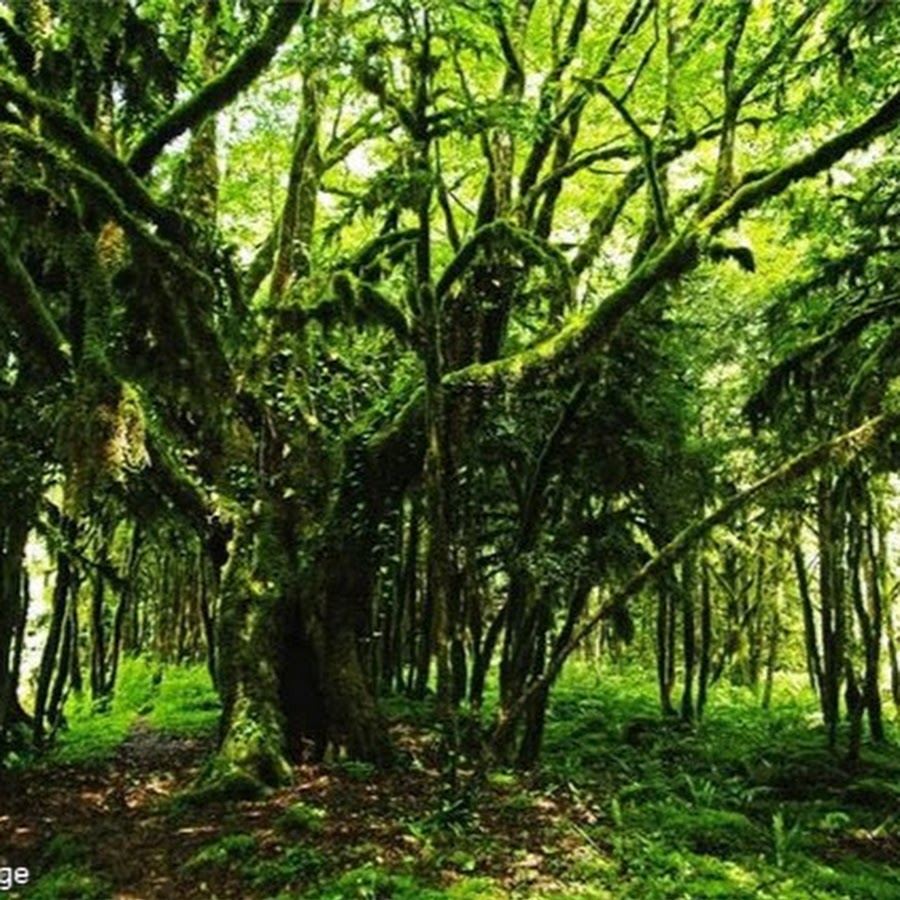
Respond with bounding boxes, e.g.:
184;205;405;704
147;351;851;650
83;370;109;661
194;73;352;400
128;0;311;176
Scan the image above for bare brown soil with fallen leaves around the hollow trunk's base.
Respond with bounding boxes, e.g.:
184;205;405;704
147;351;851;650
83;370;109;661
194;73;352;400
0;722;596;900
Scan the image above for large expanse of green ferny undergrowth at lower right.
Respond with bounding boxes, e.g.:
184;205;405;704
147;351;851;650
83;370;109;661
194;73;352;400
542;667;900;900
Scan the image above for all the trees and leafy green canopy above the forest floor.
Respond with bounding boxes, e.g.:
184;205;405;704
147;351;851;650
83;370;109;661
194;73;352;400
0;0;900;892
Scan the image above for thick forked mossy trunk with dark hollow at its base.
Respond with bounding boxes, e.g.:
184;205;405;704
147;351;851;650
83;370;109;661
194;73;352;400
213;401;424;783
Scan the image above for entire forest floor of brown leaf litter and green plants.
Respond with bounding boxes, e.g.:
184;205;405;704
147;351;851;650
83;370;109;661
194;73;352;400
0;656;900;900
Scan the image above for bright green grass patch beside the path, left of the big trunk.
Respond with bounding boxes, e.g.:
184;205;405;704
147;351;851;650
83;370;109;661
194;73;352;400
49;657;219;765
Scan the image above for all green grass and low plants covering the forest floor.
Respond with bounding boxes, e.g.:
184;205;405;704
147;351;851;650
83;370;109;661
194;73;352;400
14;659;900;900
